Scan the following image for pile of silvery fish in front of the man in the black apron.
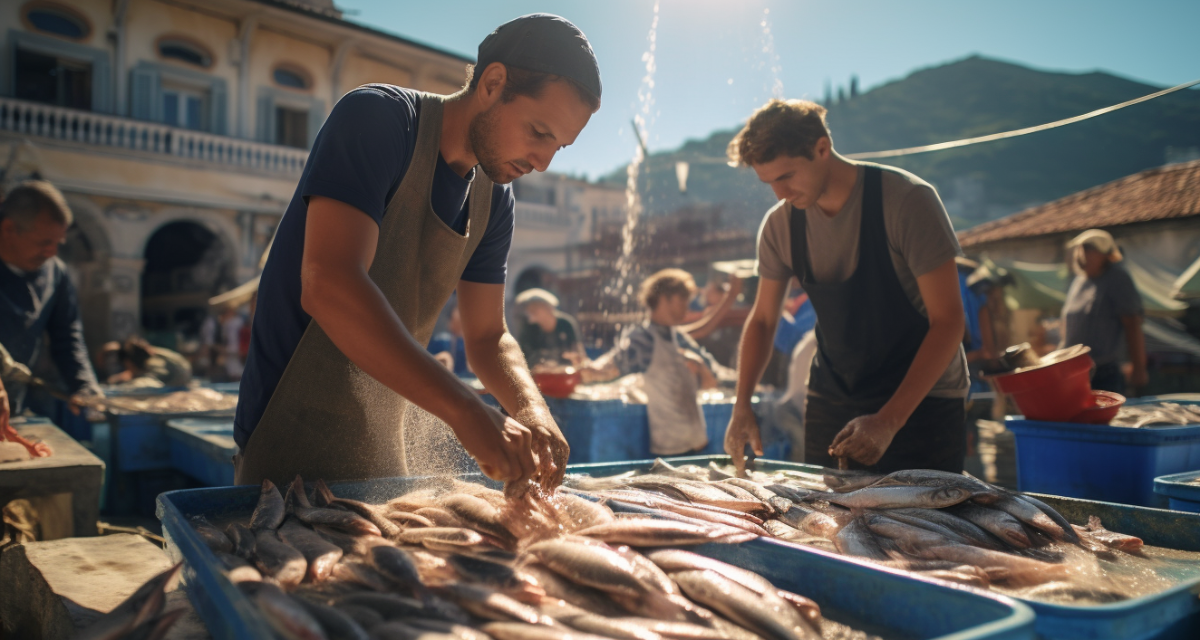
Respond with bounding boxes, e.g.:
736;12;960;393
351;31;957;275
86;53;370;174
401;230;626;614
566;460;1142;602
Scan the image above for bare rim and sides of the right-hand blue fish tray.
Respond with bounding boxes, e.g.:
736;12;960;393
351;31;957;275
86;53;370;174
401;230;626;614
572;456;1200;640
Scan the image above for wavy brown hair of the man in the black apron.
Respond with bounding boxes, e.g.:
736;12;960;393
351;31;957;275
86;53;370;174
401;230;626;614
726;98;829;167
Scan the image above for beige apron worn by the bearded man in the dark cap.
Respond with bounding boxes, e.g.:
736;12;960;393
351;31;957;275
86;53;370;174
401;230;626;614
235;94;492;486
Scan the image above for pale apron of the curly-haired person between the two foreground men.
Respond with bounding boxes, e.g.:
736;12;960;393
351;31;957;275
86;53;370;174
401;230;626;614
643;327;708;455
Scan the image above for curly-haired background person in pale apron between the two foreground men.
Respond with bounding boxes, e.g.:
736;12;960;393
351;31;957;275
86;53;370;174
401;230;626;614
582;269;722;455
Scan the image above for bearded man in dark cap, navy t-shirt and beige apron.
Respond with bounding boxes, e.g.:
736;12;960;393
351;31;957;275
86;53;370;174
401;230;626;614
234;14;601;486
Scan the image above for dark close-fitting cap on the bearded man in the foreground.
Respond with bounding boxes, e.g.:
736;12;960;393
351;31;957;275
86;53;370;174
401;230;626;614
476;13;601;100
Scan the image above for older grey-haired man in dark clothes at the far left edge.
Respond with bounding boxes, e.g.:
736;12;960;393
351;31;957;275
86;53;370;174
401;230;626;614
0;180;102;421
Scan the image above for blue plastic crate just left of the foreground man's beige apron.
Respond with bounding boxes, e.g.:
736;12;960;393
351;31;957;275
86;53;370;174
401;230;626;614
166;418;238;486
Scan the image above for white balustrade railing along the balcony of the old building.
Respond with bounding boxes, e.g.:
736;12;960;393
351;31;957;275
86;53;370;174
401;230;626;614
0;97;308;175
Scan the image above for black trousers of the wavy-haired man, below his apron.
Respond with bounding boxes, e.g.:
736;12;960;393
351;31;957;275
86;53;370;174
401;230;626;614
804;395;967;473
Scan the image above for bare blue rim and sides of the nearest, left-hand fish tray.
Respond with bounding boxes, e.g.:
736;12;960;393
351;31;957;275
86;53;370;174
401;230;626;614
158;462;1034;640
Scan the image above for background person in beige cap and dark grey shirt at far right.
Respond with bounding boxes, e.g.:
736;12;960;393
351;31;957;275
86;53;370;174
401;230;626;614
1058;229;1147;394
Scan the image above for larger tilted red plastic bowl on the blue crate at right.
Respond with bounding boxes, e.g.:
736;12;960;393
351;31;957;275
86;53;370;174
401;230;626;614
994;348;1096;423
